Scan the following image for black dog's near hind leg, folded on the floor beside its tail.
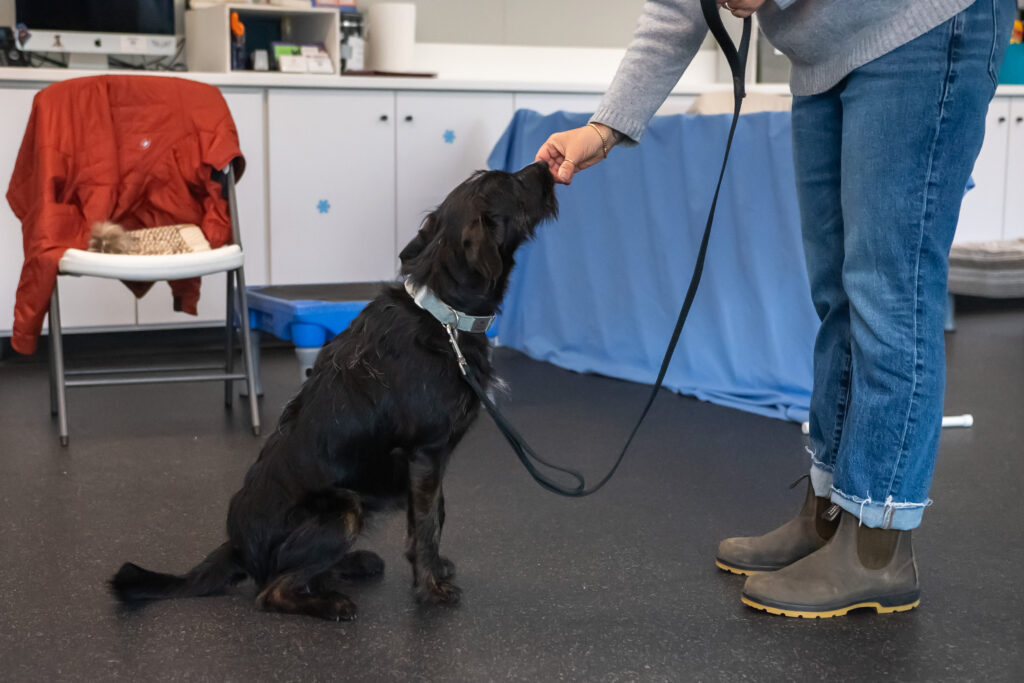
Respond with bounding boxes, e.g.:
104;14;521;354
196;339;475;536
256;488;364;621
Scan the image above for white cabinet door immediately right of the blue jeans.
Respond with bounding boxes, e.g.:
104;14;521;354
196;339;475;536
954;97;1010;242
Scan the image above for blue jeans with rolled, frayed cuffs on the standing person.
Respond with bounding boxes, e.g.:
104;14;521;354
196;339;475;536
793;0;1015;529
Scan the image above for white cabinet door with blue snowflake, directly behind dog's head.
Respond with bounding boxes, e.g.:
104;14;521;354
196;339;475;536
395;92;513;252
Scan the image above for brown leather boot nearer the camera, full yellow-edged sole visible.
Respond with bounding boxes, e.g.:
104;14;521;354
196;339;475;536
742;512;921;618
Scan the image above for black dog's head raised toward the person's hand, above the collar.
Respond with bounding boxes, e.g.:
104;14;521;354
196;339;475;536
399;162;558;315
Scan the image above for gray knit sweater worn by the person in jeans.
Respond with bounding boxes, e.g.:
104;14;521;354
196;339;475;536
591;0;970;144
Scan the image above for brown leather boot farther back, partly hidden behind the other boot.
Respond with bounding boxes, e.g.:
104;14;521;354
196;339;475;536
715;477;839;575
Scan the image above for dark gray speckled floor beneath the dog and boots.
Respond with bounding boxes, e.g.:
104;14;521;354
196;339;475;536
0;306;1024;681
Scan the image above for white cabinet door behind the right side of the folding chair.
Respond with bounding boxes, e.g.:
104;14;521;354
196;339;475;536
137;90;267;325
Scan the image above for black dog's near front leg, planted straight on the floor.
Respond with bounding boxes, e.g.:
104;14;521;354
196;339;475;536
406;451;461;604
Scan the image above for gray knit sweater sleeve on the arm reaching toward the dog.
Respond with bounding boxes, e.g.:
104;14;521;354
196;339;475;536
591;0;708;144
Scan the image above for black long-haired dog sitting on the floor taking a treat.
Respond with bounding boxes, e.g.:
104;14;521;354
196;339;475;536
111;164;557;620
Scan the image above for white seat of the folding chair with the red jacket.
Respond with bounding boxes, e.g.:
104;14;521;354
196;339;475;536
59;245;245;282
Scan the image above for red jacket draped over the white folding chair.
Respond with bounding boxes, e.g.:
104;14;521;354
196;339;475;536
7;76;245;353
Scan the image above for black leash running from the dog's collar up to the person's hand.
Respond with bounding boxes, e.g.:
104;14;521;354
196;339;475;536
445;0;751;498
